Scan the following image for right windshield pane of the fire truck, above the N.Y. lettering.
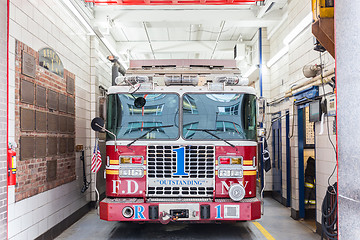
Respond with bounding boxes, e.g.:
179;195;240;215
182;93;256;140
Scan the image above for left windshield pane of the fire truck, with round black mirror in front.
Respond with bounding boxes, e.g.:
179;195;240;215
106;93;180;140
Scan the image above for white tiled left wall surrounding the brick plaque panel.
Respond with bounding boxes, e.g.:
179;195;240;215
7;0;111;239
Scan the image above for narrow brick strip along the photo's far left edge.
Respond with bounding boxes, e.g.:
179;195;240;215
0;1;7;239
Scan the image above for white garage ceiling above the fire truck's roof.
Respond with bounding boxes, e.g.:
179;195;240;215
92;0;287;62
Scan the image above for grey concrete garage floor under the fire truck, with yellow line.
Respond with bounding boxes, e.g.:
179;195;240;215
56;198;320;240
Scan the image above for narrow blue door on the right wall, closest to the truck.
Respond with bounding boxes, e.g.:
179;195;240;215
272;112;282;203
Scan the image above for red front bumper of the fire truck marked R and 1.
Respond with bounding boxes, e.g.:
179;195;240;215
100;198;261;223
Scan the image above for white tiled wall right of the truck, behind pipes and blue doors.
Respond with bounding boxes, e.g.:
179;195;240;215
267;0;336;222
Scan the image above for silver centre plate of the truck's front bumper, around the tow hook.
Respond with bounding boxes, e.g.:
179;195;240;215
159;203;200;221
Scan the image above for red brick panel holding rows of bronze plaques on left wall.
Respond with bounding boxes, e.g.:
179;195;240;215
15;41;75;201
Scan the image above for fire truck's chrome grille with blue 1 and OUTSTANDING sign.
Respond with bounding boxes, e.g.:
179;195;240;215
147;146;215;197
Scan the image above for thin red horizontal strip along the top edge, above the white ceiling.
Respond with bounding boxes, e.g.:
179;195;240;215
85;0;264;6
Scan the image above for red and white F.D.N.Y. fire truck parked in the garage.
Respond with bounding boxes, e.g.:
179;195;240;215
93;60;261;223
